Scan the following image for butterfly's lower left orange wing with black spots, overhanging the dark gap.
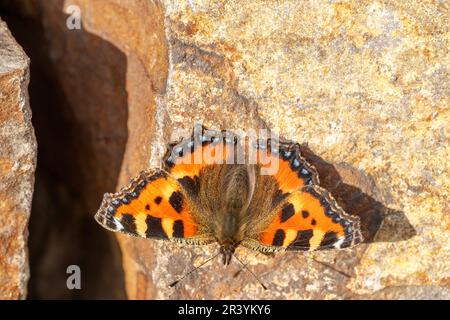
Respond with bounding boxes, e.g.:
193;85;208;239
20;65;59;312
95;170;198;240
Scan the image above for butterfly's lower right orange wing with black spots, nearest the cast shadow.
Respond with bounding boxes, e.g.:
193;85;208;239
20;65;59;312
259;186;362;251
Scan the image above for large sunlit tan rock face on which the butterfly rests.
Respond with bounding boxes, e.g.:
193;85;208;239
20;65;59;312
24;0;450;299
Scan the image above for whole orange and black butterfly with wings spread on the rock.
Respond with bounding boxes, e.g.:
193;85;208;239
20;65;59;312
95;127;363;265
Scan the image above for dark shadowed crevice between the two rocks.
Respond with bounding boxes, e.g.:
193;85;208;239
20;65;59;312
5;5;128;299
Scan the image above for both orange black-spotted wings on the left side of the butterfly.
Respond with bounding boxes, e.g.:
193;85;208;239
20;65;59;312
95;127;236;243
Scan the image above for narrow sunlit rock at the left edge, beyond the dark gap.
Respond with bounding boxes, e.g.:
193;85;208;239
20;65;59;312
0;20;37;300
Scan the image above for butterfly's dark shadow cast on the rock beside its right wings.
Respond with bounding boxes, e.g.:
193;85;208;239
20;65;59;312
301;146;416;243
